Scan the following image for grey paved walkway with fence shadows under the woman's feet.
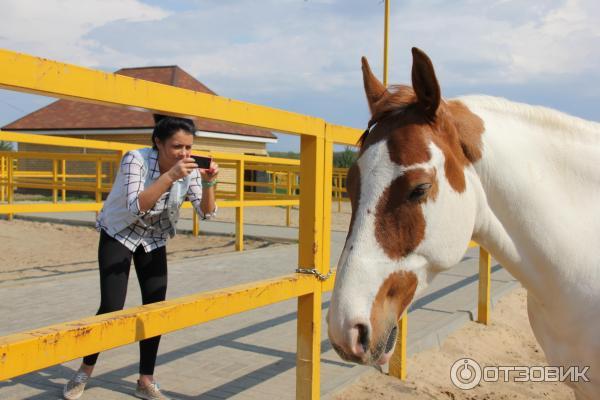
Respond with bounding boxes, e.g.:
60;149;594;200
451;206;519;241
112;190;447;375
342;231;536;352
0;213;517;400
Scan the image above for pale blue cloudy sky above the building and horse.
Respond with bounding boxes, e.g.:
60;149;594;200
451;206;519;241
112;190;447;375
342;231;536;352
0;0;600;151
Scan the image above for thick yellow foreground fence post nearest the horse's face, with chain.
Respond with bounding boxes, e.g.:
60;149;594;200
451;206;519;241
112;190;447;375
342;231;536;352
296;125;325;400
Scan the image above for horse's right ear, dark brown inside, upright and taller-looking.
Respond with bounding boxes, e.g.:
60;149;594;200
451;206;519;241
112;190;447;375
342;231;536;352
412;47;442;120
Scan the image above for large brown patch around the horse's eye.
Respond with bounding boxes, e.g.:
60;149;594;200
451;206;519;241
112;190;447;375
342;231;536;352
375;169;437;260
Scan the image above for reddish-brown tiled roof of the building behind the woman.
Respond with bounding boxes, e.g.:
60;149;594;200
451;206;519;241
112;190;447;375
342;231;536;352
2;66;276;138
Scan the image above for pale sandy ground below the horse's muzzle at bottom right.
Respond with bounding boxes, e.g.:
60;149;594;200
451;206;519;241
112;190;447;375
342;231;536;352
334;288;575;400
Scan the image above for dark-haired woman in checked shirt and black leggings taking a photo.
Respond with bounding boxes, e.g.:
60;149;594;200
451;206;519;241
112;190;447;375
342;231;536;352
63;115;219;400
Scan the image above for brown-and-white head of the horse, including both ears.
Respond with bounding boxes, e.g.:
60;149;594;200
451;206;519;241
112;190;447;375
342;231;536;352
328;48;483;364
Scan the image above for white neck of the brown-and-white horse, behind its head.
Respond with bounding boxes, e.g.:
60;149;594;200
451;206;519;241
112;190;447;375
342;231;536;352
461;97;600;302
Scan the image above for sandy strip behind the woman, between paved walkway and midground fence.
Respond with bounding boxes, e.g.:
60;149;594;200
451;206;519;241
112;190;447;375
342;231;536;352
0;219;277;282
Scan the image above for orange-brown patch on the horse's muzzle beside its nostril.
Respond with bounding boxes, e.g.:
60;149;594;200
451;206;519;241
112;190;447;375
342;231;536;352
370;271;418;352
